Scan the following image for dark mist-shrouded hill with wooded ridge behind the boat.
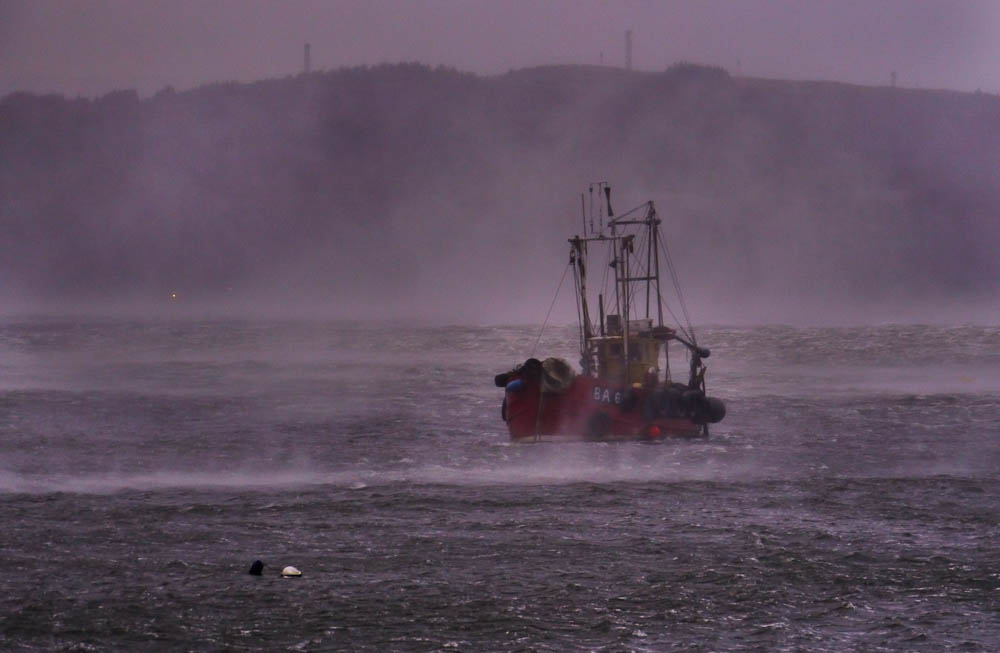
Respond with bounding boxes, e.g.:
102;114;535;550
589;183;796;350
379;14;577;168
0;64;1000;322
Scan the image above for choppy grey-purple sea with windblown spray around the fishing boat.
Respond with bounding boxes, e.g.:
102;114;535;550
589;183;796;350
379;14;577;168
0;318;1000;651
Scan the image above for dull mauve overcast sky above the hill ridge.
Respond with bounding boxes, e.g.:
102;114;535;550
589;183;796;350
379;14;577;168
0;0;1000;96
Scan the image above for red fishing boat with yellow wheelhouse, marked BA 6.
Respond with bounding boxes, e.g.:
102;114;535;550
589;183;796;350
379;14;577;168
494;182;726;441
